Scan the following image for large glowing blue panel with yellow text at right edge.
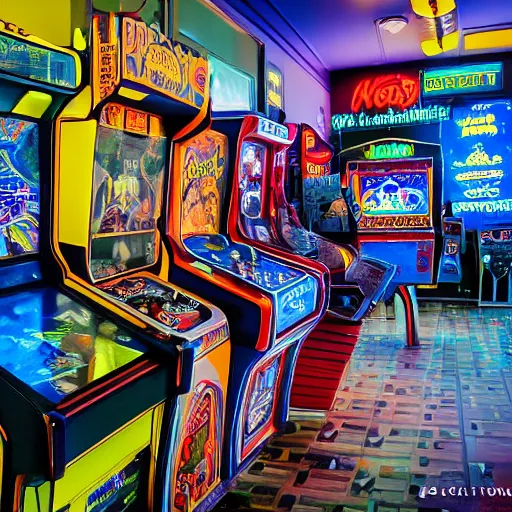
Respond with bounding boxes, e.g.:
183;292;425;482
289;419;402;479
441;100;512;229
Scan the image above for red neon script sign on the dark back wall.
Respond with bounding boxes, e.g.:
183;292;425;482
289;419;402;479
351;74;420;113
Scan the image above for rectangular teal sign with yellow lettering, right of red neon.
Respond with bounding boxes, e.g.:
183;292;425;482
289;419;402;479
422;62;503;98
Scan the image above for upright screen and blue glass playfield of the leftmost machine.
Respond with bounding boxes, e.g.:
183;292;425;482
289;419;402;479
0;117;145;403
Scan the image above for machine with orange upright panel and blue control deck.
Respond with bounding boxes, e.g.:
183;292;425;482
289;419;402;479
167;117;325;478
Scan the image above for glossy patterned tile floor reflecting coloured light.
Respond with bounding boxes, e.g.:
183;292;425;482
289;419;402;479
217;305;512;512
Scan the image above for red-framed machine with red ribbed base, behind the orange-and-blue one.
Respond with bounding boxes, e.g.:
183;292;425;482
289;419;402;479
230;116;394;410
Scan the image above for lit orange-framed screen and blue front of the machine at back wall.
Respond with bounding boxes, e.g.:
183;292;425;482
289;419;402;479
347;159;434;284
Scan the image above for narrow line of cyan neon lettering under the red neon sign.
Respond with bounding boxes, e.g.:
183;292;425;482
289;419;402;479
331;105;451;131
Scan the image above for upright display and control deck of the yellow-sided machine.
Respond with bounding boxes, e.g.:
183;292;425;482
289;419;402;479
90;104;211;332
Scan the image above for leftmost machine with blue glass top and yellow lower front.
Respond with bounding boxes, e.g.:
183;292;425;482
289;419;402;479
0;20;168;512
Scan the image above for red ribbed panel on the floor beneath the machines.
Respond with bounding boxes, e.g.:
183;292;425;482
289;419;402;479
290;313;361;411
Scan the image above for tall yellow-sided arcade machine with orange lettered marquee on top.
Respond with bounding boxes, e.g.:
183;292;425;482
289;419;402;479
53;14;230;512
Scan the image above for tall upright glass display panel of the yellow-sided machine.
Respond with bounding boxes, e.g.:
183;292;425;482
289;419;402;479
90;103;166;280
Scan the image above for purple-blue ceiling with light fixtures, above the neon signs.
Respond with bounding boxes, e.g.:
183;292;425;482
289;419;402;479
255;0;512;70
